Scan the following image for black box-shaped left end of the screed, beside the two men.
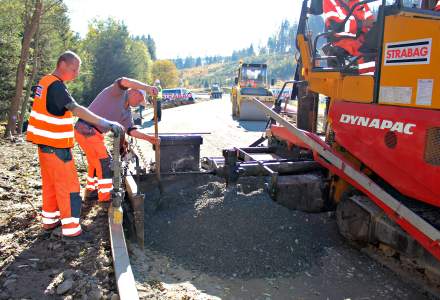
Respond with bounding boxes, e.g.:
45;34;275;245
124;134;207;246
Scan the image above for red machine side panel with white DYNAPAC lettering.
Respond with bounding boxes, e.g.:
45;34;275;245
329;101;440;206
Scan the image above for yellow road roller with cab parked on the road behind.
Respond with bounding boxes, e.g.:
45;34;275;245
231;61;275;121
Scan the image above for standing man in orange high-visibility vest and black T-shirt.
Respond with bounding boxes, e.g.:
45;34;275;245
26;51;122;239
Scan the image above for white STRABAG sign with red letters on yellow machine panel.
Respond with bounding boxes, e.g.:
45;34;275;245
384;38;432;66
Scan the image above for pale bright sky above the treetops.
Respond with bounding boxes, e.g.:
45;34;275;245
64;0;301;58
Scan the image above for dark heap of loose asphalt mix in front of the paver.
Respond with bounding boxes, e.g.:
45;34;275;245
146;176;340;278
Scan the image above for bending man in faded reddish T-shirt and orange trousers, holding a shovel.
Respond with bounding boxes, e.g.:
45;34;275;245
75;77;158;202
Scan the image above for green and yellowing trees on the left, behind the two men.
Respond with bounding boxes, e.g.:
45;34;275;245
0;0;179;136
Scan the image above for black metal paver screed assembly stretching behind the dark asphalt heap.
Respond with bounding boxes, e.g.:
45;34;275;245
120;135;326;246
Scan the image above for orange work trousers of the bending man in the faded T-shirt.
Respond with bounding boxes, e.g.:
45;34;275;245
75;128;113;202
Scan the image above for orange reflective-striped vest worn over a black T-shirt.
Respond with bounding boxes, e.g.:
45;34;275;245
26;74;74;148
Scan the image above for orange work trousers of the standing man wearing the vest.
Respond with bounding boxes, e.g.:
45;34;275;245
38;145;81;236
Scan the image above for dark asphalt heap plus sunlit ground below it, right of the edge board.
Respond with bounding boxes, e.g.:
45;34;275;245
129;175;429;299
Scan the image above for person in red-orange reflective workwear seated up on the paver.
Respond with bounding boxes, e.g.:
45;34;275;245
323;0;374;72
